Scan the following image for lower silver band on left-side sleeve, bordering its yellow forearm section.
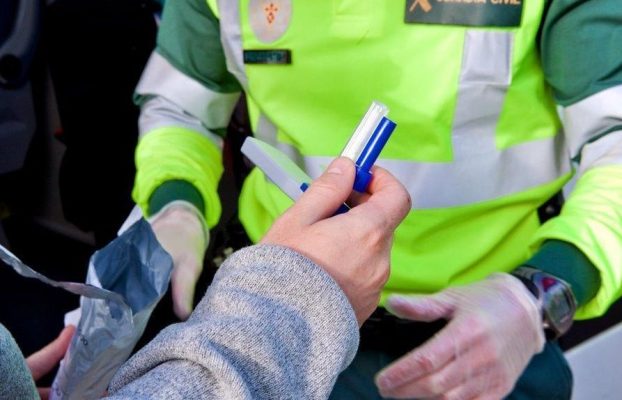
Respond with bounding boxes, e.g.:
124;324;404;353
138;96;223;149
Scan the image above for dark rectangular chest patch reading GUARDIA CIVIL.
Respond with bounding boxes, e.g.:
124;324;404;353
404;0;523;27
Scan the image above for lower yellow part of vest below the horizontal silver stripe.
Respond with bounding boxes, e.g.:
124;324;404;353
240;169;568;304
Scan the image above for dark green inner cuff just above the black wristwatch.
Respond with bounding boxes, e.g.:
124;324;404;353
525;240;601;306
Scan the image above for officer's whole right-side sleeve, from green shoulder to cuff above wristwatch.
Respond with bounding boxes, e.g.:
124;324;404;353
527;0;622;319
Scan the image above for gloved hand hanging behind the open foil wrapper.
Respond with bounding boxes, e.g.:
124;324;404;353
149;201;209;320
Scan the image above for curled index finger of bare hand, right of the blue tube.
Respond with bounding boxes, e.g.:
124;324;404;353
359;167;411;229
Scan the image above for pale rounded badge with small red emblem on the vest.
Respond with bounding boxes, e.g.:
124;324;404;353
248;0;292;43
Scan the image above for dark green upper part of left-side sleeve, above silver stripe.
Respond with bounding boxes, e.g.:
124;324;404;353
156;0;241;93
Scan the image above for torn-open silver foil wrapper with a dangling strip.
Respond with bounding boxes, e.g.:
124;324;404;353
0;219;173;400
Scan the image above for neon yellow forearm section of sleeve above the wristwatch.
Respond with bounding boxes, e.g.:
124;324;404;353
532;165;622;319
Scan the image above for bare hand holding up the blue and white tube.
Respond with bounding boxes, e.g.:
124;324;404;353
262;158;410;325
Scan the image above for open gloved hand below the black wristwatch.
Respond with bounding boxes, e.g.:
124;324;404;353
376;273;545;400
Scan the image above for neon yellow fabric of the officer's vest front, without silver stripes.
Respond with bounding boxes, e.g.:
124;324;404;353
240;0;568;298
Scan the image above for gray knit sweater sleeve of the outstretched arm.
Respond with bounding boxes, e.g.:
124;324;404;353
109;245;359;400
